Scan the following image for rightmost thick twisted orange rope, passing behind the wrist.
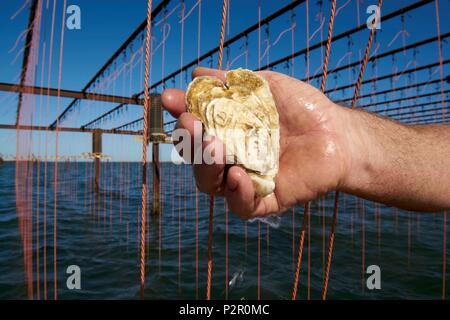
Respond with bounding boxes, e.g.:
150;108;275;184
322;0;383;300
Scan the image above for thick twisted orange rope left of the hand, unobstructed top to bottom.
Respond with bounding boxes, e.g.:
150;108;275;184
140;0;152;299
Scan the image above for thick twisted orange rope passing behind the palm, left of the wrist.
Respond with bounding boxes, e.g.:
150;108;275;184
292;0;336;300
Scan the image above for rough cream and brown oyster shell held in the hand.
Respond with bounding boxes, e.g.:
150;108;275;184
186;69;280;197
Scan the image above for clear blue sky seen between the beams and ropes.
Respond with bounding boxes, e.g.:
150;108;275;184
0;0;450;161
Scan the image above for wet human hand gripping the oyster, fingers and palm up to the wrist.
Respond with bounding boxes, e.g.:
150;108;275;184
162;68;348;218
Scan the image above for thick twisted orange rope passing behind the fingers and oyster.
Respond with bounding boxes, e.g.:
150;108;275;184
206;0;228;300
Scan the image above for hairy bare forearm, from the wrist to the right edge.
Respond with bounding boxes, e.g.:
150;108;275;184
339;108;450;211
